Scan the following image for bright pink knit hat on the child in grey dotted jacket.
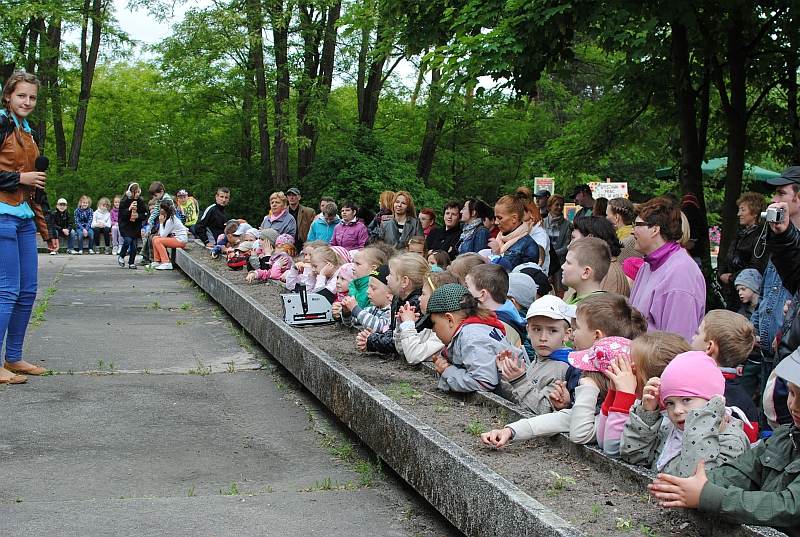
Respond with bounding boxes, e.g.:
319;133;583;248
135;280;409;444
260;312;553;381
661;351;725;405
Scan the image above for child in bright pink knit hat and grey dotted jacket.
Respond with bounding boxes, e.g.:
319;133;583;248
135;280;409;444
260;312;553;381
620;351;750;477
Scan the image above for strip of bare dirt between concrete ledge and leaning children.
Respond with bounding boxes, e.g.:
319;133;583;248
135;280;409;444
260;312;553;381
186;249;704;537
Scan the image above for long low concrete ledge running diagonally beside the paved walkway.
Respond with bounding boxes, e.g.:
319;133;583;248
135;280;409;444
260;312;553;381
176;250;582;537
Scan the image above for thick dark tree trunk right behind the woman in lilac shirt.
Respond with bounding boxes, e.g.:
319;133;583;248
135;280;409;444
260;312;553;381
671;21;711;274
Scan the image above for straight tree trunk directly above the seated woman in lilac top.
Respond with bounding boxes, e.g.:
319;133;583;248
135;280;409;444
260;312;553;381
270;0;291;188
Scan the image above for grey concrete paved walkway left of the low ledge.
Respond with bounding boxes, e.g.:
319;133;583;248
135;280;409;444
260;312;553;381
0;255;455;537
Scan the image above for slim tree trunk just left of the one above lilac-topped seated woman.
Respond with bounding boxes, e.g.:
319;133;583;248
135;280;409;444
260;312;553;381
245;0;272;186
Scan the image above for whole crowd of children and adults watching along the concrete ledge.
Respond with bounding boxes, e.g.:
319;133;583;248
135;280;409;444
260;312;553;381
50;183;800;531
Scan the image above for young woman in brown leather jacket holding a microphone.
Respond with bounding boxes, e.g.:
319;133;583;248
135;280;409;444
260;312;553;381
0;71;56;384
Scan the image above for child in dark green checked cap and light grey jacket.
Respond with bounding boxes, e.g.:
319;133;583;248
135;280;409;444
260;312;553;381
427;283;524;392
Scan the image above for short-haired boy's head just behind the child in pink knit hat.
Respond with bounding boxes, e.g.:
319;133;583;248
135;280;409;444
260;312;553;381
692;310;756;367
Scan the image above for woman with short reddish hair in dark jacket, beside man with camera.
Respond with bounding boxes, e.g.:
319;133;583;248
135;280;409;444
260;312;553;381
717;192;768;311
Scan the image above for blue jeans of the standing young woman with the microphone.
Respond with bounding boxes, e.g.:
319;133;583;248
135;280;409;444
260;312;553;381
0;214;39;363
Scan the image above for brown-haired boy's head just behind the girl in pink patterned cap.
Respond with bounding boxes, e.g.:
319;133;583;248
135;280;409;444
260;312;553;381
572;294;647;350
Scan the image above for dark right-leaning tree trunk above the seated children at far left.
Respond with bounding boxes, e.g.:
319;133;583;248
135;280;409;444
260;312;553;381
68;0;104;171
